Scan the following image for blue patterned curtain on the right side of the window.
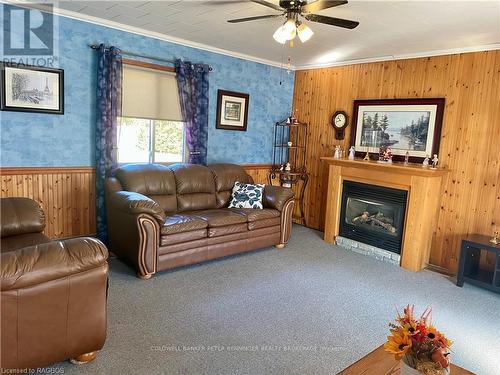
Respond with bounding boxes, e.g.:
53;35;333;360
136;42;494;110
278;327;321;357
175;60;209;165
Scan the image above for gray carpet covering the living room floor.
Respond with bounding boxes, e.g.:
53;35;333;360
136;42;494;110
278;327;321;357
55;226;500;375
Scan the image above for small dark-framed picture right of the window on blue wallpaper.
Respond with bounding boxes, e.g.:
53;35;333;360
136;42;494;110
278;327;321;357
215;90;250;131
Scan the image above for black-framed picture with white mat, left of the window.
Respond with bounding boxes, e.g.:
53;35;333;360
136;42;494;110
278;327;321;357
0;63;64;115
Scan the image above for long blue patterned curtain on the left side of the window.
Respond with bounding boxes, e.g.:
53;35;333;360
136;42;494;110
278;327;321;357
95;44;122;242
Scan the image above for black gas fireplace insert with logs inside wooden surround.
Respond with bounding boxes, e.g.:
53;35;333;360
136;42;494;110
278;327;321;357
339;180;407;254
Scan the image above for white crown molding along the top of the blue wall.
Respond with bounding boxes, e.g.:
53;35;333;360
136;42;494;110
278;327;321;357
0;0;295;70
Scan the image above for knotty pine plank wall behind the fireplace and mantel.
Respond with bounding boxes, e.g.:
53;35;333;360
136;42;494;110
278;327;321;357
293;50;500;272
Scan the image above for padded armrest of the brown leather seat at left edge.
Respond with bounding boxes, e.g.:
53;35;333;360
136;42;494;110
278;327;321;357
0;237;108;291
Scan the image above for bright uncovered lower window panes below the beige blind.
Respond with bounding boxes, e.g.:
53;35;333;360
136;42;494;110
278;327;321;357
118;117;184;163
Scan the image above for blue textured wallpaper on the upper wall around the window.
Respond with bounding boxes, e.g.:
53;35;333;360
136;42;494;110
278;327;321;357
0;5;294;166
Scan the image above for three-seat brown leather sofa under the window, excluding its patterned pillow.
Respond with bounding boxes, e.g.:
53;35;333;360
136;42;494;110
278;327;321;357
106;164;294;279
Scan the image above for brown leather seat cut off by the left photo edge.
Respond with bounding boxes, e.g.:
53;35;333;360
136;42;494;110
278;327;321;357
0;198;108;373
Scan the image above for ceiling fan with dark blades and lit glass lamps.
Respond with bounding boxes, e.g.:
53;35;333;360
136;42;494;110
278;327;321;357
227;0;359;44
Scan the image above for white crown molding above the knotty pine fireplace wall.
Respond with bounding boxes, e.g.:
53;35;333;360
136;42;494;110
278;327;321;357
294;43;500;71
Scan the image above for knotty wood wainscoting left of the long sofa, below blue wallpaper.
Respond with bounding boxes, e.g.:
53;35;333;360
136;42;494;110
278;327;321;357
0;167;95;238
